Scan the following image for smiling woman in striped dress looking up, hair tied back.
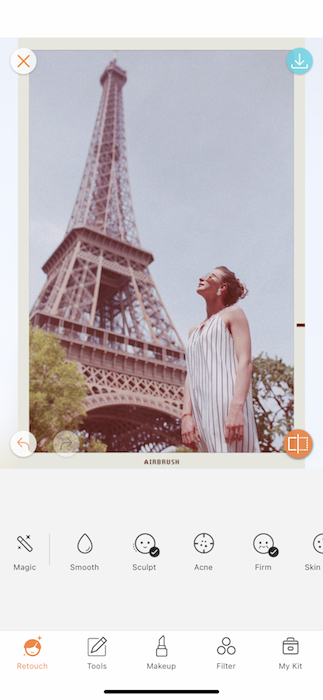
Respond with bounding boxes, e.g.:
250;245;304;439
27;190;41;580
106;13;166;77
182;267;259;452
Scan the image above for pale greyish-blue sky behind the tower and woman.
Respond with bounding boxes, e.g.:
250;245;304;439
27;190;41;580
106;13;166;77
30;50;294;364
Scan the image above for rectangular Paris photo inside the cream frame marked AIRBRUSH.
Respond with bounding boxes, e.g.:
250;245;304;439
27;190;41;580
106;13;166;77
29;50;294;457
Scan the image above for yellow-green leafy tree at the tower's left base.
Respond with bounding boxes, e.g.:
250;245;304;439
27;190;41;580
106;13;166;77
29;327;87;452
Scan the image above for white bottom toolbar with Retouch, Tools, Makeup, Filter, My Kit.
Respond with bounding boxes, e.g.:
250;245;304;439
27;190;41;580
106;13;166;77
0;628;323;700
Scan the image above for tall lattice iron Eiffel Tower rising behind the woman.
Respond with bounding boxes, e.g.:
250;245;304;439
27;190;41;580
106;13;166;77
31;59;186;452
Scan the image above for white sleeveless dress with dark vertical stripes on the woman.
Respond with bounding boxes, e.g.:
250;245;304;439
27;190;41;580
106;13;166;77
186;313;260;452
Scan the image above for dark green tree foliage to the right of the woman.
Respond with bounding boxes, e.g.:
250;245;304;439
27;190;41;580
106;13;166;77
252;353;294;452
